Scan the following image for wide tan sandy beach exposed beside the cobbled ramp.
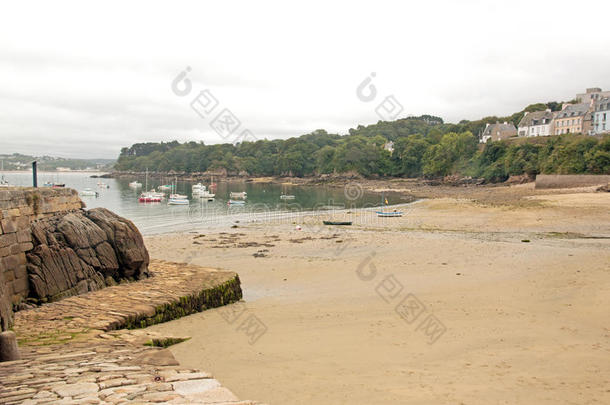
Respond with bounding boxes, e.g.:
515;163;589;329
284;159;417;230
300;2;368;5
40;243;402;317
146;187;610;405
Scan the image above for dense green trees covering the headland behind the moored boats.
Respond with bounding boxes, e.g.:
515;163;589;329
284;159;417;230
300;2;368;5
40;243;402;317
115;103;610;182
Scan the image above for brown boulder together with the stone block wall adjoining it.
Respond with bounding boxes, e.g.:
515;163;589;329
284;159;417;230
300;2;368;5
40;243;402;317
0;188;149;330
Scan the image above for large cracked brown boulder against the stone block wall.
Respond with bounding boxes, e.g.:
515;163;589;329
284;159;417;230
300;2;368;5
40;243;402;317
27;208;149;302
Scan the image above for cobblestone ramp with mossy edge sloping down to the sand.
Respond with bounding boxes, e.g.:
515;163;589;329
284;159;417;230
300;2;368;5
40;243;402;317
0;261;256;405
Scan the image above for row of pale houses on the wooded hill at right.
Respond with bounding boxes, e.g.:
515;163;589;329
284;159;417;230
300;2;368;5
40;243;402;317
480;87;610;143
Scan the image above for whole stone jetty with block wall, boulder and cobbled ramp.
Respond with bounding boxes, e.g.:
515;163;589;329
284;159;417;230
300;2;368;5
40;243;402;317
0;188;264;405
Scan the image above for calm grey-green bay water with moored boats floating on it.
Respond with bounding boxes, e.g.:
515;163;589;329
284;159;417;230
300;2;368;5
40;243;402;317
4;172;384;234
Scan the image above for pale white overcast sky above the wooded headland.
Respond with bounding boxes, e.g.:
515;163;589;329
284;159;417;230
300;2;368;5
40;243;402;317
0;0;610;158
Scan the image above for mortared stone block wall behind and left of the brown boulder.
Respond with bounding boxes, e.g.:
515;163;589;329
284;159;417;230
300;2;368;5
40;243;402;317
0;187;84;305
